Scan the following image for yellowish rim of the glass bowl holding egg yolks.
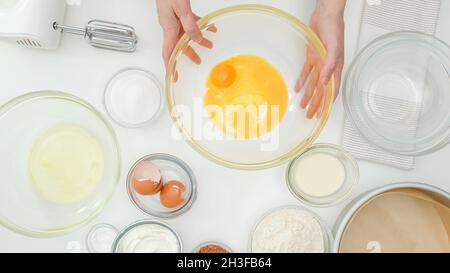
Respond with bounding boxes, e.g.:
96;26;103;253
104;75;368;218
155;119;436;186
166;4;335;170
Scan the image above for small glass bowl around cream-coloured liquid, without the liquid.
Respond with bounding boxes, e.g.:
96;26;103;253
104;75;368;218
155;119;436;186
286;144;359;207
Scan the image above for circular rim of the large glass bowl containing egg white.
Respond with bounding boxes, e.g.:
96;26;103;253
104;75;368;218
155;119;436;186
0;90;122;238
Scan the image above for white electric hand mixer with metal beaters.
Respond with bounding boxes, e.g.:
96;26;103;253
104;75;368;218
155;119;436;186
0;0;138;52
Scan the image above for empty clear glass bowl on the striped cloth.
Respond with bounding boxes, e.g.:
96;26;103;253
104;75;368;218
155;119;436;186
343;32;450;155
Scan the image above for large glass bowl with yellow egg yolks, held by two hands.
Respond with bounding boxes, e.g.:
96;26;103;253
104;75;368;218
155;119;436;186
166;5;334;169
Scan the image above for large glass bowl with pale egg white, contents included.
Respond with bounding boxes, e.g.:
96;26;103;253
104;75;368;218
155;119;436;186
0;91;121;237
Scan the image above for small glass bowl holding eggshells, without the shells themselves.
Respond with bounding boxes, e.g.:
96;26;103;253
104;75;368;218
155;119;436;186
127;154;197;219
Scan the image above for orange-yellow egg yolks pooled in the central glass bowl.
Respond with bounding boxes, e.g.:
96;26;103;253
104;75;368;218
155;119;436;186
204;55;288;139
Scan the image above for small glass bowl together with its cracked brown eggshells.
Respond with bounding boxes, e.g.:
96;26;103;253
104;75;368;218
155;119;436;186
127;154;197;219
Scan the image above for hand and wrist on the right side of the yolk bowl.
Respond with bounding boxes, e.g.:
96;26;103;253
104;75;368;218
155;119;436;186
295;0;346;119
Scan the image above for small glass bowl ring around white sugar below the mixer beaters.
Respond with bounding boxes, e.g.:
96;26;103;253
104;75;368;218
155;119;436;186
103;67;165;128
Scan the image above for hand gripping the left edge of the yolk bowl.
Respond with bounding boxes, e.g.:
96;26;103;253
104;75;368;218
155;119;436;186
156;0;212;67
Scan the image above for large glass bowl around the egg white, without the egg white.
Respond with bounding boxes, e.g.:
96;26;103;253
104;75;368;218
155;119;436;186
0;91;121;237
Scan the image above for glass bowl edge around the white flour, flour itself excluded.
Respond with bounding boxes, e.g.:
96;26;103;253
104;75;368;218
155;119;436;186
248;205;334;253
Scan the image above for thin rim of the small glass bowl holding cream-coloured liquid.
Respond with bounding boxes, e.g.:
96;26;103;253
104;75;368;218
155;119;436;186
285;143;360;208
